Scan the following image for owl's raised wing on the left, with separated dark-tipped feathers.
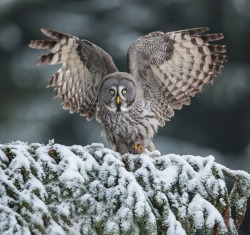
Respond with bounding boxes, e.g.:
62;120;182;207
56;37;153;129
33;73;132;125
29;29;117;120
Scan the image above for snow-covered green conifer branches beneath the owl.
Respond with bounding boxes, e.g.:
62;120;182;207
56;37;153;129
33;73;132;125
0;142;250;235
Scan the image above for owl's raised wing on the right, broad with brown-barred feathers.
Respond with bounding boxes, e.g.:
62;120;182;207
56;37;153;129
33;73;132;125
128;27;226;125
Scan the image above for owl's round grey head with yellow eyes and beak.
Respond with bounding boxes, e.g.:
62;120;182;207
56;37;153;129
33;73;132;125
99;72;136;112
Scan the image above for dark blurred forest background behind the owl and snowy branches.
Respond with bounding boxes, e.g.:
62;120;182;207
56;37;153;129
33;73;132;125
0;0;250;234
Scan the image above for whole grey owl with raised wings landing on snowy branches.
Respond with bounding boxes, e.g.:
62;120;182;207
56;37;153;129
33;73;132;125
29;27;226;154
